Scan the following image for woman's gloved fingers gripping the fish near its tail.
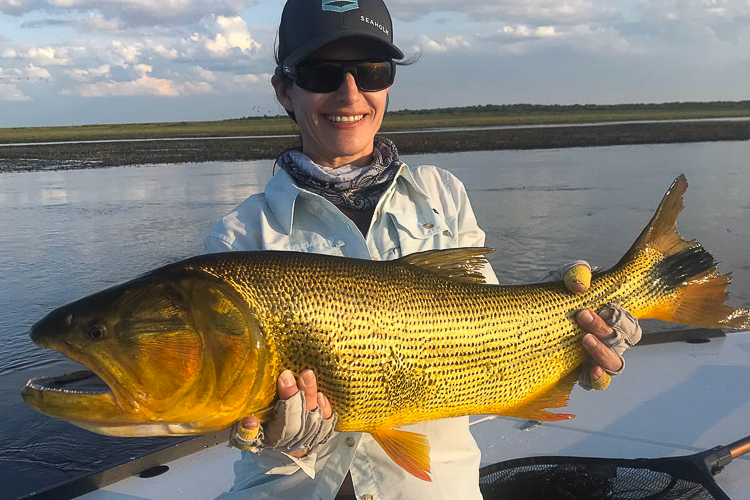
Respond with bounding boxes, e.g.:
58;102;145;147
576;304;642;389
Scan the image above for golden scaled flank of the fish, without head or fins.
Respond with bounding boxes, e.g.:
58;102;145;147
194;252;607;431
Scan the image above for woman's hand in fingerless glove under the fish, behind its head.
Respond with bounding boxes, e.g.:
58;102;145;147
232;370;336;458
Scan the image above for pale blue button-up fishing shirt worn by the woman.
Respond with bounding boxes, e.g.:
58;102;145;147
205;164;497;500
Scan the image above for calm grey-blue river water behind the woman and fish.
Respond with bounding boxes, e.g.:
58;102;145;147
0;142;750;498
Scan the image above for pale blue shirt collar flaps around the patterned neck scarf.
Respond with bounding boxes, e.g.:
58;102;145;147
266;162;434;234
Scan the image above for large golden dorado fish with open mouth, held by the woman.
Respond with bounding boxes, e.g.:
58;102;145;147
23;176;750;479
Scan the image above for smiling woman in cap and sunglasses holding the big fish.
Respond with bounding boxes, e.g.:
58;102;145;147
206;0;639;500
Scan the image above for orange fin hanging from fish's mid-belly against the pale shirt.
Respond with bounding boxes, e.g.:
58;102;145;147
370;429;432;481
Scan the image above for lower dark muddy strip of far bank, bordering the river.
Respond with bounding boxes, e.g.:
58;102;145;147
0;119;750;173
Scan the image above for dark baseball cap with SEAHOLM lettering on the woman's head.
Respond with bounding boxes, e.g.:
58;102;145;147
278;0;404;72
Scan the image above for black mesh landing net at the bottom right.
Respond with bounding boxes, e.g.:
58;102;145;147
479;457;728;500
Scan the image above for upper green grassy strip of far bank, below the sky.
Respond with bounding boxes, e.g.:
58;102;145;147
0;101;750;143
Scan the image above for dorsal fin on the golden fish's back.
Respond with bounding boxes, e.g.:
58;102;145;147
396;247;494;284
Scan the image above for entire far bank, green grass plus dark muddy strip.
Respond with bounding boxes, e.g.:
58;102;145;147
0;101;750;173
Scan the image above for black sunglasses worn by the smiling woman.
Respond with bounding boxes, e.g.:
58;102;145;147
284;59;396;94
